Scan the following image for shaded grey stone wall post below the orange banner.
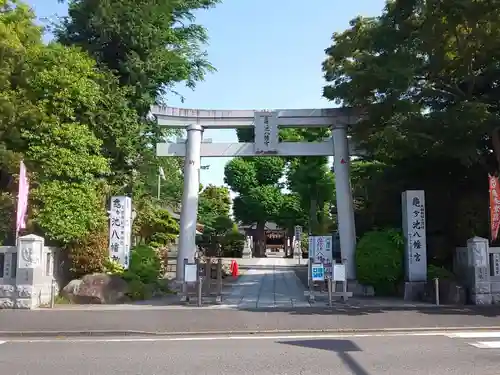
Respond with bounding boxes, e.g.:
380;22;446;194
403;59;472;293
453;237;500;305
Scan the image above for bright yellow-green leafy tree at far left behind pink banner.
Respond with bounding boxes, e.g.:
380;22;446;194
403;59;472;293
0;2;116;243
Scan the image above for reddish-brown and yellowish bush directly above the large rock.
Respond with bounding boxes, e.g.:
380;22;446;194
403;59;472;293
66;229;109;278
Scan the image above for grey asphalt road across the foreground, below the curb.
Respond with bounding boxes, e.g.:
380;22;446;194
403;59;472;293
0;333;500;375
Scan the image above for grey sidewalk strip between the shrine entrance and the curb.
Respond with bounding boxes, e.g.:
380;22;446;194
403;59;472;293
0;307;500;336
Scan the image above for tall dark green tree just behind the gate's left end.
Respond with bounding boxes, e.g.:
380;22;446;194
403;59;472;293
55;0;218;204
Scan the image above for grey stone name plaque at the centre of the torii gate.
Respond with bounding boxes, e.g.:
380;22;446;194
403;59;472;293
254;112;279;154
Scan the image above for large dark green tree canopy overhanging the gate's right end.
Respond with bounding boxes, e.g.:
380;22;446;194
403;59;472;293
323;0;500;164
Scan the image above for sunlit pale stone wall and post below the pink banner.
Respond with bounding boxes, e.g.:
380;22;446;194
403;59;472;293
0;235;57;309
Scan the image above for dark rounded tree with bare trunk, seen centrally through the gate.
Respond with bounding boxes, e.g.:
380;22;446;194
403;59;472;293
224;157;285;256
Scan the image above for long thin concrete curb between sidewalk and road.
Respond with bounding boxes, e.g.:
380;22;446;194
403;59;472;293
0;326;500;338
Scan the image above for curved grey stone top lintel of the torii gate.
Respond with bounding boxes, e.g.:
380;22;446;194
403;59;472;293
151;106;363;129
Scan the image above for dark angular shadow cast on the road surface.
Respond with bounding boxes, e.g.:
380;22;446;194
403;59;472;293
277;339;370;375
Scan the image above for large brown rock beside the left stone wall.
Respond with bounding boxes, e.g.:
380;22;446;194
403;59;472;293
61;273;128;304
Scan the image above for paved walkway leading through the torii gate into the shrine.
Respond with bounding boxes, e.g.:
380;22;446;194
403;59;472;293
223;258;310;309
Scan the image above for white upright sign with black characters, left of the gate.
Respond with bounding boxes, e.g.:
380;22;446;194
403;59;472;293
109;196;132;269
